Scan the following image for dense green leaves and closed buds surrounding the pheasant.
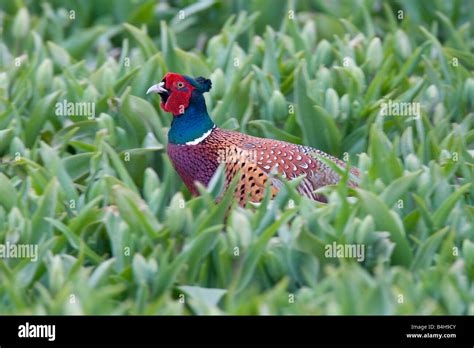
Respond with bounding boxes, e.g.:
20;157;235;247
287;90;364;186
0;0;474;314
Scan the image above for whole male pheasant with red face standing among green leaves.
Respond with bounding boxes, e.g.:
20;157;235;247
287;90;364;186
147;73;359;206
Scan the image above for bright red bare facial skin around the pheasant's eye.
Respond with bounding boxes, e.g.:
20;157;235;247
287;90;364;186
160;73;194;116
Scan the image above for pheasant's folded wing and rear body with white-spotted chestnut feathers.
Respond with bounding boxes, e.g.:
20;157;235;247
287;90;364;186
219;130;359;204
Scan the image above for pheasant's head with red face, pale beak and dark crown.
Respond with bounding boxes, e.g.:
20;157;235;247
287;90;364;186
146;73;212;116
